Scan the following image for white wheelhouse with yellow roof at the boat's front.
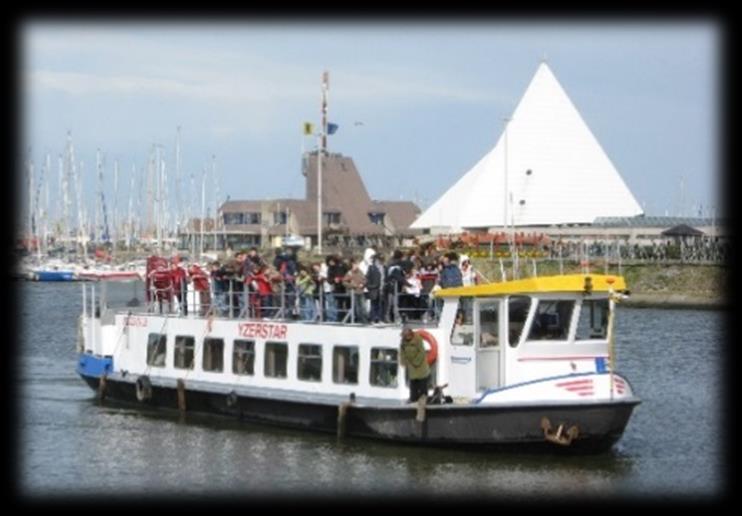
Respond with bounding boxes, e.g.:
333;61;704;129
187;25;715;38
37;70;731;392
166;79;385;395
438;274;626;399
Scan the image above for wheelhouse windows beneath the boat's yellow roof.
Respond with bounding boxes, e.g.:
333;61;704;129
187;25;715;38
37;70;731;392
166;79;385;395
451;296;609;347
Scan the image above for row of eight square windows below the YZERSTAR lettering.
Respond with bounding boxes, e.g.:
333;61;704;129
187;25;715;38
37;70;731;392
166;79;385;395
147;333;398;387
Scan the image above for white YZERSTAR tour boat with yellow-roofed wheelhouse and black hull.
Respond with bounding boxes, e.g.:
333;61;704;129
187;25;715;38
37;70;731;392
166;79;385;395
77;274;640;451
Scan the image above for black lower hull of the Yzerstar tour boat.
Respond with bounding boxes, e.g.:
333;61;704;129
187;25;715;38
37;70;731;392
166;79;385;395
80;373;639;452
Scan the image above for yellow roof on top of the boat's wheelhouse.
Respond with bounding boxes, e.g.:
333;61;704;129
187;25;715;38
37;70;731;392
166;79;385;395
434;274;626;297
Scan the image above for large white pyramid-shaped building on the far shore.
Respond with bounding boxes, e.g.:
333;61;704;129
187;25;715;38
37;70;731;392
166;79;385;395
411;63;642;232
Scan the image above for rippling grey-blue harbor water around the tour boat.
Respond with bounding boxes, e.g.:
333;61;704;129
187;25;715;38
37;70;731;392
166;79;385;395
15;282;726;500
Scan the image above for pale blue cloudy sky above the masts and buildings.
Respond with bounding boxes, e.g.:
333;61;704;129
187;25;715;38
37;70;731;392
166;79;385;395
21;20;721;226
